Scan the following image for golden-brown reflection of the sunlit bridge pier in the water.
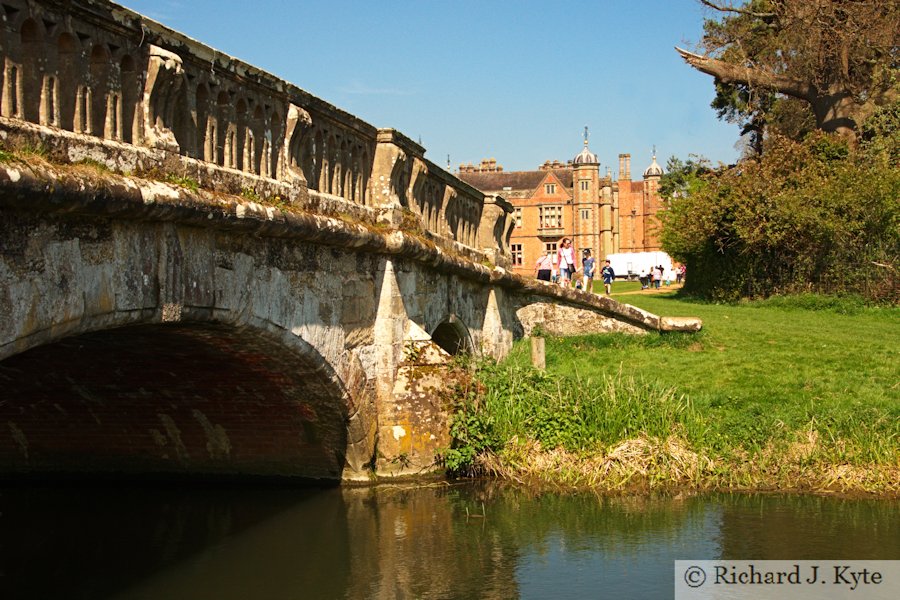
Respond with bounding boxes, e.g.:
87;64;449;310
343;484;518;599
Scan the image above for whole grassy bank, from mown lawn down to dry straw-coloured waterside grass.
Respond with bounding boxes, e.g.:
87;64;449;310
447;292;900;495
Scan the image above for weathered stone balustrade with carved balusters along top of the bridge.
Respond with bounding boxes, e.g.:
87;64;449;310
0;0;512;266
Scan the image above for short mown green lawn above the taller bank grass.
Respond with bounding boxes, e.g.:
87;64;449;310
580;292;900;460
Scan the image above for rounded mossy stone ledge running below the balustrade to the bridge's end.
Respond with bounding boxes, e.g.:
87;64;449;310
0;159;702;332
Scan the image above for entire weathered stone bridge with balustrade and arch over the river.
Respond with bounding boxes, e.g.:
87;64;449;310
0;0;699;480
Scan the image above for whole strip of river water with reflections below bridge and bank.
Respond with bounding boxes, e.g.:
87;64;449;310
0;482;900;600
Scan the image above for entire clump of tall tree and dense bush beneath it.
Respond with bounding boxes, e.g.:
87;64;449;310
661;0;900;303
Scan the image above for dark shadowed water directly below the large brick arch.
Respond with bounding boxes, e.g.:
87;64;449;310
0;486;349;600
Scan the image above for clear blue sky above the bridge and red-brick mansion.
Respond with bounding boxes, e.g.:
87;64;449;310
120;0;739;176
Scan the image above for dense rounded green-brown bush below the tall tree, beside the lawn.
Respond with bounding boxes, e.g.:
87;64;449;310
661;125;900;302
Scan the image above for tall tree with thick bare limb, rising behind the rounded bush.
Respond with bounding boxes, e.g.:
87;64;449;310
676;0;900;143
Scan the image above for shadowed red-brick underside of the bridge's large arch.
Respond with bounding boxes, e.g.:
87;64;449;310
0;323;347;481
